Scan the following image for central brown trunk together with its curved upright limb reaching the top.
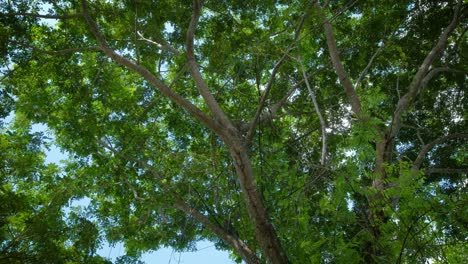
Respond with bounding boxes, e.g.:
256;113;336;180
187;0;289;263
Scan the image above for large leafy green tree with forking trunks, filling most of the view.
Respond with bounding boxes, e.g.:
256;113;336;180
0;0;468;263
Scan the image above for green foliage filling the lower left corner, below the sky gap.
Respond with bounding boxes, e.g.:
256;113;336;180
0;123;107;263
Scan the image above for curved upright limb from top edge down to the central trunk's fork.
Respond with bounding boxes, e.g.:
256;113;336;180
187;0;236;135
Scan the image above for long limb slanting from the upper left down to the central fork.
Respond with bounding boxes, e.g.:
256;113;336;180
81;0;223;136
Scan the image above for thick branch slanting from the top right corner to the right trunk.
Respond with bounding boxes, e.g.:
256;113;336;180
389;1;461;138
